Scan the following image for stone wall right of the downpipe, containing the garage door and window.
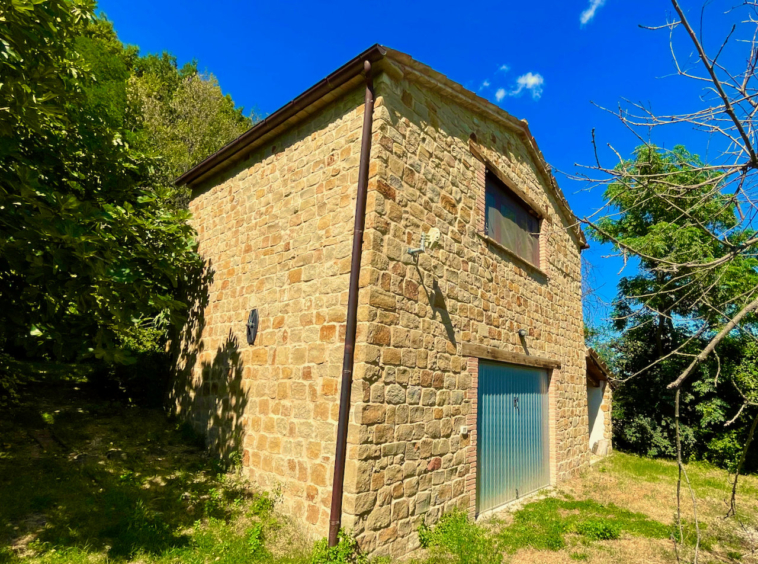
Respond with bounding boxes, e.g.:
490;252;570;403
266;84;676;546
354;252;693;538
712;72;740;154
344;68;589;555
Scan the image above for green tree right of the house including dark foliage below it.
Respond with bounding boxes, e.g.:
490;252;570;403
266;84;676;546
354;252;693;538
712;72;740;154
591;145;758;465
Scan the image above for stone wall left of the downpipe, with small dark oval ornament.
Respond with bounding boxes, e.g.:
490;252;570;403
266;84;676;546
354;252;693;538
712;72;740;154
172;88;363;536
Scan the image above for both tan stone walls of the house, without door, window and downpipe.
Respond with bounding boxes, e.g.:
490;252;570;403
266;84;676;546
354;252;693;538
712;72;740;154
172;60;592;555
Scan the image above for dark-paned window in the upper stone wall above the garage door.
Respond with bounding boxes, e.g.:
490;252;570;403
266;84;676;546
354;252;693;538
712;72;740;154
484;171;540;266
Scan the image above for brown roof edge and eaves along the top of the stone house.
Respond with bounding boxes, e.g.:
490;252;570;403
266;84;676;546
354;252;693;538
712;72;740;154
176;44;588;248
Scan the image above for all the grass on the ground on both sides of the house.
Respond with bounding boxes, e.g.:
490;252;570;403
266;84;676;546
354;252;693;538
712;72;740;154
0;375;758;564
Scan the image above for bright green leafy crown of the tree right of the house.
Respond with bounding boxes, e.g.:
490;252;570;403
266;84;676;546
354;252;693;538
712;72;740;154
590;145;758;338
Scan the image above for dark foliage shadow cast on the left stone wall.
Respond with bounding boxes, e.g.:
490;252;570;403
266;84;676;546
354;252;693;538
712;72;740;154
168;261;247;460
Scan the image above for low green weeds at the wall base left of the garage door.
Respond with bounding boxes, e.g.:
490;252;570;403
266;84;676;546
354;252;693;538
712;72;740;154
418;510;503;564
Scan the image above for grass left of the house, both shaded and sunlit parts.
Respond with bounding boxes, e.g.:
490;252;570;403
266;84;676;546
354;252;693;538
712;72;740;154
0;380;310;564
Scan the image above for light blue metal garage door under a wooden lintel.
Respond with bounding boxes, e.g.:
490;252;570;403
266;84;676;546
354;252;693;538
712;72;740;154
476;361;550;513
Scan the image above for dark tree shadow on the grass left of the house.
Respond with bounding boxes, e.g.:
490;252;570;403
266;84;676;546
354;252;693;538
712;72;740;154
0;376;254;562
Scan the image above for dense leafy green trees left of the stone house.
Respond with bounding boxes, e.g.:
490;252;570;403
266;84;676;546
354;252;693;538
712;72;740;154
0;0;251;398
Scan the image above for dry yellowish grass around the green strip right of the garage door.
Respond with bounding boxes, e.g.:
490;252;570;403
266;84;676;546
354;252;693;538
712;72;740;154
502;453;758;564
